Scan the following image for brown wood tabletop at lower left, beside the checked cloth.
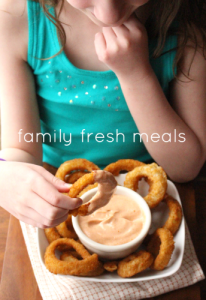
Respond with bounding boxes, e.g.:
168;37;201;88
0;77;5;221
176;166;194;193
0;216;41;300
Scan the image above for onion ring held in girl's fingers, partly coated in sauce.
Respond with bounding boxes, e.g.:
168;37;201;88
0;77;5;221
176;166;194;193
69;170;117;216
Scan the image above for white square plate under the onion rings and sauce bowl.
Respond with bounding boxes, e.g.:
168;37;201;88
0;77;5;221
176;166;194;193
37;174;185;285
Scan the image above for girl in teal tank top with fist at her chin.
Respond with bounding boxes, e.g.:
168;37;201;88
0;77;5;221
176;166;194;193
0;0;206;228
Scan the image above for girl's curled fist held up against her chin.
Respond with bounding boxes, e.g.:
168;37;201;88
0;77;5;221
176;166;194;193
95;15;151;80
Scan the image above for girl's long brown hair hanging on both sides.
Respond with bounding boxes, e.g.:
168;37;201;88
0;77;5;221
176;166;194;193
33;0;206;78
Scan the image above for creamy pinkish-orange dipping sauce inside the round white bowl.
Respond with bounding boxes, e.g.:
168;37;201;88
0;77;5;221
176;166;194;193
78;194;145;246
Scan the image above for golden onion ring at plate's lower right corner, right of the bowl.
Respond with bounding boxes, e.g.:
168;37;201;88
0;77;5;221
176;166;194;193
147;228;174;270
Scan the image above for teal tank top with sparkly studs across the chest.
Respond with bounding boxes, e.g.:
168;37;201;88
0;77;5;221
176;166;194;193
27;0;177;168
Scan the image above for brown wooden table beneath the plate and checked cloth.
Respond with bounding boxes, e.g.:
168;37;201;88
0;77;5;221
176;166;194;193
0;166;206;300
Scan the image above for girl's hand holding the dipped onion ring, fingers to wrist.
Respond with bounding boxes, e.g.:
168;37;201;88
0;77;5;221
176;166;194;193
0;162;82;228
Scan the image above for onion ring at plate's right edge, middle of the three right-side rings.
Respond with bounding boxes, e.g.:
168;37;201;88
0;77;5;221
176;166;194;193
163;195;182;235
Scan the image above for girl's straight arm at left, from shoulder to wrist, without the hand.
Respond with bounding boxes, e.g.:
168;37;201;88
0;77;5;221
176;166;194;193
0;0;42;165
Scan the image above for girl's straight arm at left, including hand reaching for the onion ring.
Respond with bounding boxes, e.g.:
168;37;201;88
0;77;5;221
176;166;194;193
0;0;82;228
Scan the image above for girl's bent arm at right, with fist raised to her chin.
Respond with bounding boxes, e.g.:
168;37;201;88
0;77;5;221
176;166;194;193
95;18;206;182
